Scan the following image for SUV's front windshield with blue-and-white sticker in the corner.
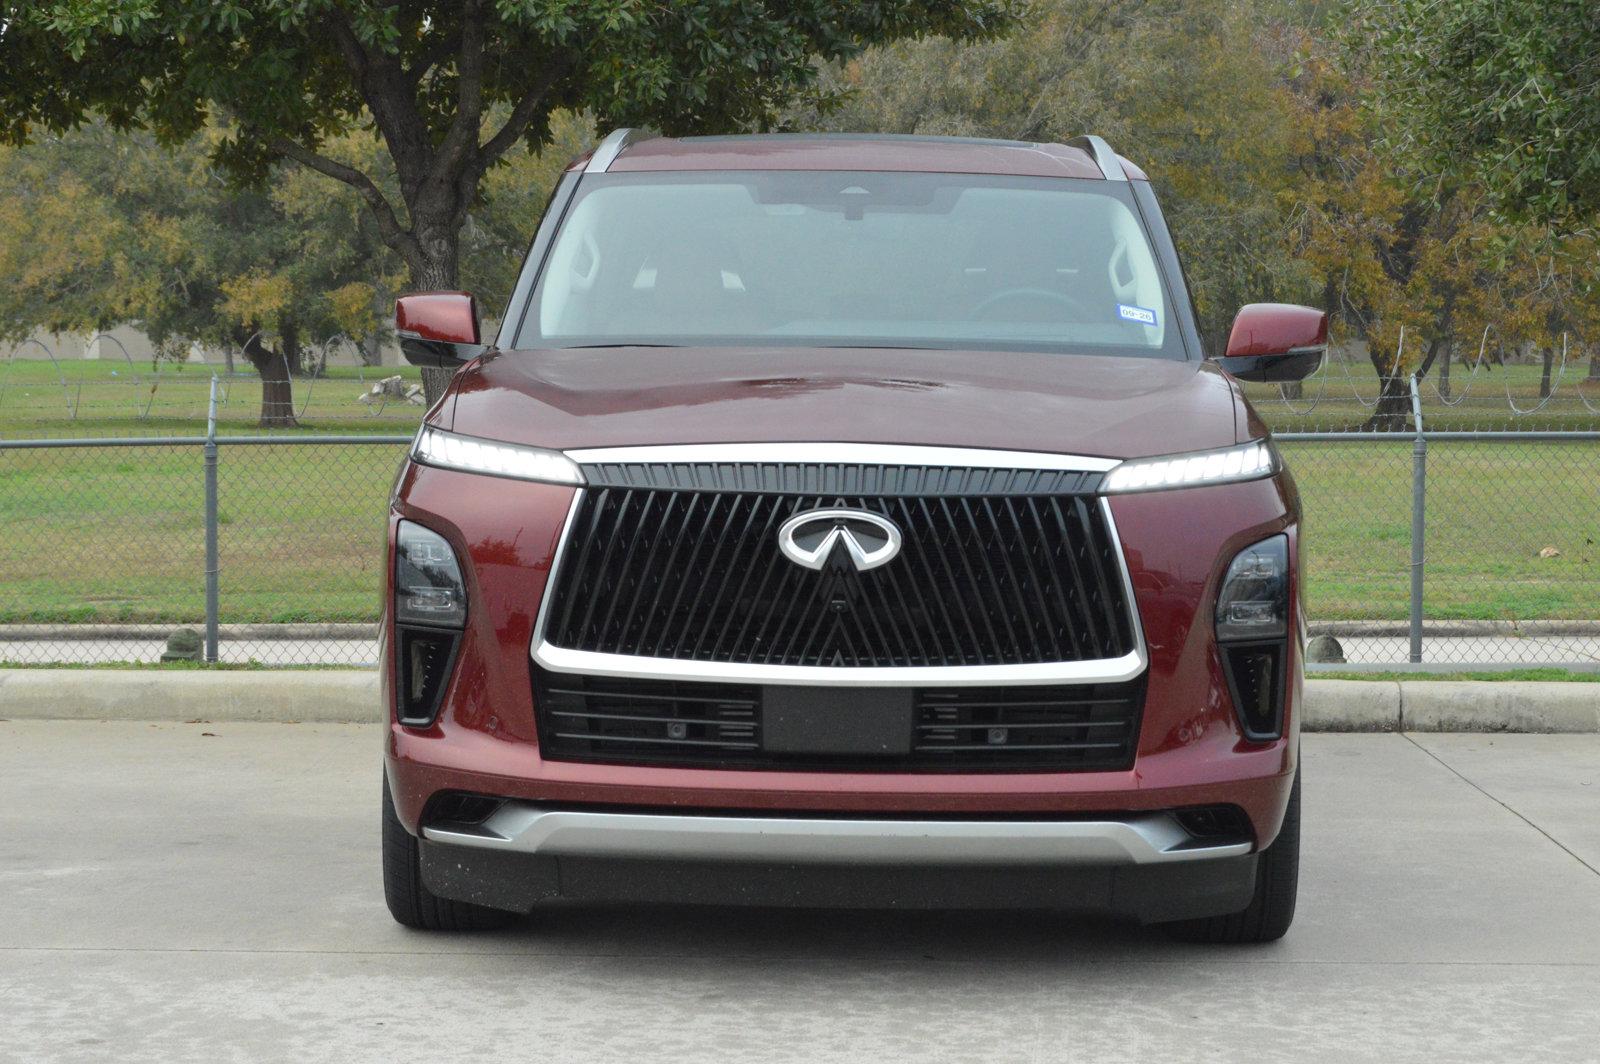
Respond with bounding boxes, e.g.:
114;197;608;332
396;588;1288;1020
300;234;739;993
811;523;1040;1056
517;171;1184;358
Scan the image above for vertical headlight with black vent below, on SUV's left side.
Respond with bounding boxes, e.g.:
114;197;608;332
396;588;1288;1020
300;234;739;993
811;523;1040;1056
394;522;467;728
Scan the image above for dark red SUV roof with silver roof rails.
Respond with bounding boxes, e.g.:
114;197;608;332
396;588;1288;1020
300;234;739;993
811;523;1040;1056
571;130;1147;181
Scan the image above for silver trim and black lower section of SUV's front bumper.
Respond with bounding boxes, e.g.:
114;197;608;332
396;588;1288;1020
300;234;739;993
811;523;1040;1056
421;802;1258;923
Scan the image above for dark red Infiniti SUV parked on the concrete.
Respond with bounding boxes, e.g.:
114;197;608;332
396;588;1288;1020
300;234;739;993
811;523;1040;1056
382;131;1326;941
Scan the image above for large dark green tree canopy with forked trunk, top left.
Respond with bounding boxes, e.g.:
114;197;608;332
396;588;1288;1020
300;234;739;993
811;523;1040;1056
0;0;1014;286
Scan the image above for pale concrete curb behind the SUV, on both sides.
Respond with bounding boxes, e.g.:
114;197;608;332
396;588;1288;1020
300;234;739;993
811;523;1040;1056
0;669;1600;733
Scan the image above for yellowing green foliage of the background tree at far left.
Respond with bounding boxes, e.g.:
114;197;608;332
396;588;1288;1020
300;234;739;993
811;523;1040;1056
0;123;398;352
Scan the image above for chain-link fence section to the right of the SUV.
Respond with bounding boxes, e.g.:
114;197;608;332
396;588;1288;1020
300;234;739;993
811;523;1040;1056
1277;432;1600;667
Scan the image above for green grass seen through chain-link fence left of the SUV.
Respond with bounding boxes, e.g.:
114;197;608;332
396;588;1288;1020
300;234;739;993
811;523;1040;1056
0;445;405;622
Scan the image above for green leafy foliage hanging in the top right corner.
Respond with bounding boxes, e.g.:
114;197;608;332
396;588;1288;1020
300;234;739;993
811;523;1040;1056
1362;0;1600;227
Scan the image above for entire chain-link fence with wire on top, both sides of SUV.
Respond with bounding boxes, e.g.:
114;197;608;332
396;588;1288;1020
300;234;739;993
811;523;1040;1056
0;366;1600;667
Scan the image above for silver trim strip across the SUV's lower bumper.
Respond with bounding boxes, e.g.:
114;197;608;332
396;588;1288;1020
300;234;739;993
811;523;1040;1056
422;802;1251;864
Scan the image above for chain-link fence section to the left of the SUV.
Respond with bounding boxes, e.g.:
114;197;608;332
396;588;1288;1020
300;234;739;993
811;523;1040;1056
0;435;411;666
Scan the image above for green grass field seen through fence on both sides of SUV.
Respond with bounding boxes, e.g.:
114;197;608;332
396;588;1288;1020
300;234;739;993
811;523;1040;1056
0;438;1600;622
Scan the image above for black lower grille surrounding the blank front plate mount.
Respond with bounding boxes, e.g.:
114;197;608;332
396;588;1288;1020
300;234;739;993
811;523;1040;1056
533;667;1144;773
